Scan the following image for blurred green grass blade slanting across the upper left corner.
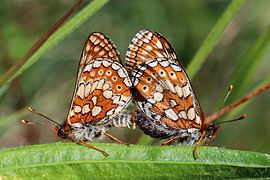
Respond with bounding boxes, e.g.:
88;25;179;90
0;0;109;96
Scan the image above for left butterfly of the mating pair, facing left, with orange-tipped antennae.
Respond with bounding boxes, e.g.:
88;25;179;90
22;32;132;155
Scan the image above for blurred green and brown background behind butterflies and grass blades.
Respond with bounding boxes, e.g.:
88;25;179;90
0;0;270;153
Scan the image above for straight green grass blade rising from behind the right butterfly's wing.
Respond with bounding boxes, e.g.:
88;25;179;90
187;0;246;79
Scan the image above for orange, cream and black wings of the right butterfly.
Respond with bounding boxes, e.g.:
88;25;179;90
126;30;204;130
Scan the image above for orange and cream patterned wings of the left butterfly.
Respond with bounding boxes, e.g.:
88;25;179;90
67;33;131;124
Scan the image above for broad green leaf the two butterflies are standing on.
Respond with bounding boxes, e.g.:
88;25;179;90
0;143;270;179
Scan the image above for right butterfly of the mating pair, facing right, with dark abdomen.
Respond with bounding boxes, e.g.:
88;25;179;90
126;30;223;157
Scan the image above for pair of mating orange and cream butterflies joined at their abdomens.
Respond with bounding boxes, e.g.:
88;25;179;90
23;30;218;158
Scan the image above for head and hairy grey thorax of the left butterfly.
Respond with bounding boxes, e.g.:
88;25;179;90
55;123;104;142
